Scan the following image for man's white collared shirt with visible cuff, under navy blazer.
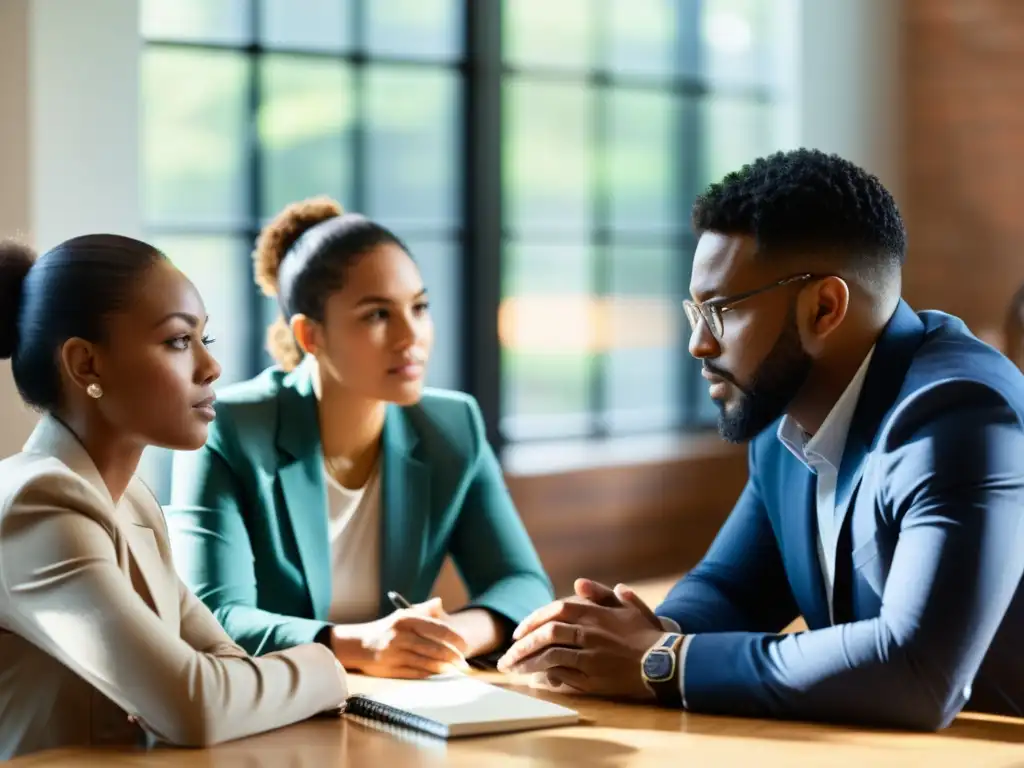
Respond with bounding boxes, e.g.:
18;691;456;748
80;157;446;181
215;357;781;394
659;346;874;708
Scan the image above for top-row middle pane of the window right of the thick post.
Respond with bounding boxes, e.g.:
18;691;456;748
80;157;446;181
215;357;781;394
607;0;679;76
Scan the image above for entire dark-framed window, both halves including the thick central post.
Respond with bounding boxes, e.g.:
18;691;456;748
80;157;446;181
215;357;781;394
141;0;775;462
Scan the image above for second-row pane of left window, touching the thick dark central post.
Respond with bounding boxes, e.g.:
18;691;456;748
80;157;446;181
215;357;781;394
367;67;461;229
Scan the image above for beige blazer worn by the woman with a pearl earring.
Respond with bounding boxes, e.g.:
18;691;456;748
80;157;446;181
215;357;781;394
0;417;346;759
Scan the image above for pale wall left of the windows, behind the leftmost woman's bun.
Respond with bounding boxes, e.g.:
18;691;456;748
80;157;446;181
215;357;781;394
0;0;141;456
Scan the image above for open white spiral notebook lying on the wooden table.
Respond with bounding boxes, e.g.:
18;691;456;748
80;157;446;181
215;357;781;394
345;673;580;738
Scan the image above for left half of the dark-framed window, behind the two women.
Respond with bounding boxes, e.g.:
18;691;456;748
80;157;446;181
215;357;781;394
142;0;464;387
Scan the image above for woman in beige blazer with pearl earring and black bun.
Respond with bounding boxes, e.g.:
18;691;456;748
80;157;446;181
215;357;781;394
0;234;346;760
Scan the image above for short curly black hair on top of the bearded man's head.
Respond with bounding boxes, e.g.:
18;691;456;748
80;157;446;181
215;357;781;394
692;150;906;278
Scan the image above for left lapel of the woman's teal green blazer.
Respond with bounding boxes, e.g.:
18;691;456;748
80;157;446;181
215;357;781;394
278;364;331;620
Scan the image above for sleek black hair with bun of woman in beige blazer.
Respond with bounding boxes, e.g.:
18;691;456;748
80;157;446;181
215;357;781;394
0;234;165;411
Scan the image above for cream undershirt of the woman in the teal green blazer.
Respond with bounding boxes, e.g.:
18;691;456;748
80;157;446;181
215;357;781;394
324;465;381;624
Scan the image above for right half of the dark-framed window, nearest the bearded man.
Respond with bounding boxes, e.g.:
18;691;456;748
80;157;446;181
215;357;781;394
500;0;772;439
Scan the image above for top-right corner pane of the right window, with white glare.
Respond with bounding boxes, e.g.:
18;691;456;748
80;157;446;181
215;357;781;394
700;0;777;85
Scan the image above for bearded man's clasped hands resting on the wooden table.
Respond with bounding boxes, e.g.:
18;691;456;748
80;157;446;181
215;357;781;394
498;579;665;699
